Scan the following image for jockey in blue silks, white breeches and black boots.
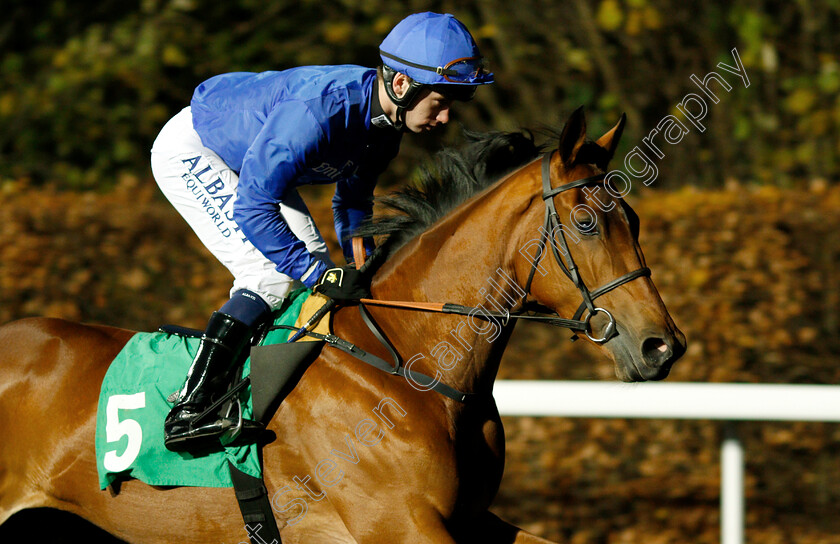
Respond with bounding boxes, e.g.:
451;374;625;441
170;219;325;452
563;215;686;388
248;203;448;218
152;13;493;451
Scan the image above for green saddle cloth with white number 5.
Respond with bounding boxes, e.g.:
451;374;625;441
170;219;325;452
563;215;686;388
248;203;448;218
96;289;311;489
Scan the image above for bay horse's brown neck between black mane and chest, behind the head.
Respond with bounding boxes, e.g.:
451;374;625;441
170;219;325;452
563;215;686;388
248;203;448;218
372;165;538;392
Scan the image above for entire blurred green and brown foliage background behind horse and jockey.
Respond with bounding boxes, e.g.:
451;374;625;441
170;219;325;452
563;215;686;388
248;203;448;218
0;0;840;544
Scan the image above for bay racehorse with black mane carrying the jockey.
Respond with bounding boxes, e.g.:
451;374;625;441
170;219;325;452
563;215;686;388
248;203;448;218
0;109;685;544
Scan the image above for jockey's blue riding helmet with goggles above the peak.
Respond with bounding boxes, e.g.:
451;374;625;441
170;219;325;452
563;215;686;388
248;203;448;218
379;12;494;118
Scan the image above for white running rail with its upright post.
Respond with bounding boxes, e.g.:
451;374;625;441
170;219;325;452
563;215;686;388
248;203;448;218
493;380;840;544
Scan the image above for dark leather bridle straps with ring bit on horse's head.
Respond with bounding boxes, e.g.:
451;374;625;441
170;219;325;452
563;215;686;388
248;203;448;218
512;152;650;344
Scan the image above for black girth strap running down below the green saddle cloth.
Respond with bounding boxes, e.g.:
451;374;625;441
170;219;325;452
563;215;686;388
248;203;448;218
228;461;282;544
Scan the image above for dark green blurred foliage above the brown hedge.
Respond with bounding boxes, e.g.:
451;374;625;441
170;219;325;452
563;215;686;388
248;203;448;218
0;0;840;189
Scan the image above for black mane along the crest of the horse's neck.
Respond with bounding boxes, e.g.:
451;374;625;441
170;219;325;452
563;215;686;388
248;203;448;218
354;129;606;260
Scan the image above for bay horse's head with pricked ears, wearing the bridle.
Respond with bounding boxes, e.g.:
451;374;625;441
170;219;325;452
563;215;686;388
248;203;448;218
516;108;686;381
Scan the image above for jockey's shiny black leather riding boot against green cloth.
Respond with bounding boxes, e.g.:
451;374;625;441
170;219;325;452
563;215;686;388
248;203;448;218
163;312;259;451
